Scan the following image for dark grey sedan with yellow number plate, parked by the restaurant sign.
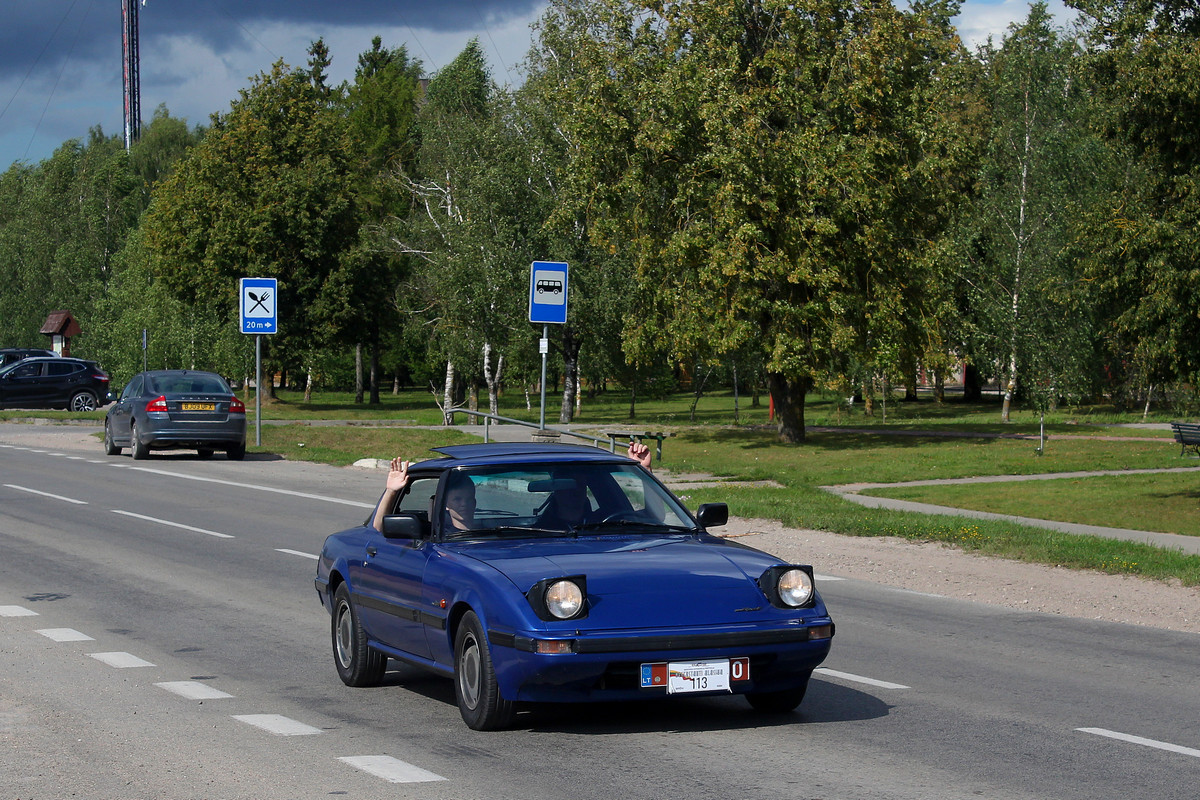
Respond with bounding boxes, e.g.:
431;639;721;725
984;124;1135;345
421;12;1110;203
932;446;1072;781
104;369;246;461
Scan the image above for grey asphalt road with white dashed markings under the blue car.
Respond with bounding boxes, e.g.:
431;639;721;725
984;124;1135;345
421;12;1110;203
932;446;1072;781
0;426;1200;800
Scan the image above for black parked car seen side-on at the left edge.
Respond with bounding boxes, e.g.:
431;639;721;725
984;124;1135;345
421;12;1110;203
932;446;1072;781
0;356;108;411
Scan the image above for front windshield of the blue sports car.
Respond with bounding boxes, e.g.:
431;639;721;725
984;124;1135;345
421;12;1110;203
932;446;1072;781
443;463;696;539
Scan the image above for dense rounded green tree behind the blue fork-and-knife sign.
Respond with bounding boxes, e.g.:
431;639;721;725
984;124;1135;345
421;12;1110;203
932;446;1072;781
144;61;358;388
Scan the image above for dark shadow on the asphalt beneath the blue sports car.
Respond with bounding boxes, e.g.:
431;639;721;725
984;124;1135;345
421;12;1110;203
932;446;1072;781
383;661;893;735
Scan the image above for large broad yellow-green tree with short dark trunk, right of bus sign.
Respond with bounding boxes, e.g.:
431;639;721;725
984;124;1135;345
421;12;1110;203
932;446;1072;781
533;0;965;441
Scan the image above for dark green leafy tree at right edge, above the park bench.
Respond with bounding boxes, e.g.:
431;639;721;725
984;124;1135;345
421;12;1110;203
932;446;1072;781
1069;0;1200;393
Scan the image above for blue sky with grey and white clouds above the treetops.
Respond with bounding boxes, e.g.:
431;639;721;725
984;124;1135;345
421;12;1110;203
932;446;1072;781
0;0;1072;170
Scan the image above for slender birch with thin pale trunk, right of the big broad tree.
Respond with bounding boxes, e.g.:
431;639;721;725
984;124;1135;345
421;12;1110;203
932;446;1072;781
967;2;1094;422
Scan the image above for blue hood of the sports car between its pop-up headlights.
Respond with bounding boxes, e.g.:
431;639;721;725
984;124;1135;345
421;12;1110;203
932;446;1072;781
446;536;782;630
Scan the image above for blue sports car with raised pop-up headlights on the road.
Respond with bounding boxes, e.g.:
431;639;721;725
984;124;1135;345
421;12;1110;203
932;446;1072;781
316;444;834;730
